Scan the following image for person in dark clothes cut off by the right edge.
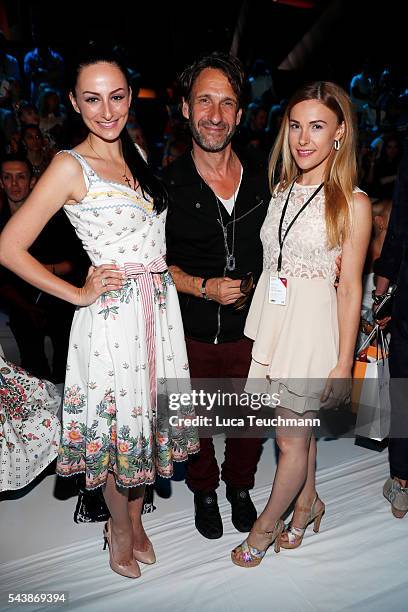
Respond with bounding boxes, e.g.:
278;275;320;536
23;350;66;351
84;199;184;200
374;154;408;518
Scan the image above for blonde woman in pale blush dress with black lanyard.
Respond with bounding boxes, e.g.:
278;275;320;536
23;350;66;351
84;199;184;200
231;82;371;567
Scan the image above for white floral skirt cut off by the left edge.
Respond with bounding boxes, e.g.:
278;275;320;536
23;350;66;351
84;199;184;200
0;346;61;491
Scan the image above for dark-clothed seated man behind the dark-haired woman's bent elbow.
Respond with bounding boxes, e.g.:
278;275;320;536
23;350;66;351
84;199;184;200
0;155;85;382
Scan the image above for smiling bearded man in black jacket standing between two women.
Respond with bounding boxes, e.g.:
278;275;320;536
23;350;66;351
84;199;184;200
163;53;270;538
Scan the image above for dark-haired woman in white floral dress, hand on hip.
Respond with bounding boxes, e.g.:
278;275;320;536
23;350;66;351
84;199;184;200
0;47;198;578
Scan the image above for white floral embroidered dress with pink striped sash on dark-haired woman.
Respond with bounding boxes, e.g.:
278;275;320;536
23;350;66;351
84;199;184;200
57;151;198;489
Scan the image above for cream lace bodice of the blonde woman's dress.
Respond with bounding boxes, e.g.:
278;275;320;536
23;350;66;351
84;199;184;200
261;183;341;282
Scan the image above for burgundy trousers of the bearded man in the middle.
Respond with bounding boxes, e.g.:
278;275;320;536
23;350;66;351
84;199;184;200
186;338;262;492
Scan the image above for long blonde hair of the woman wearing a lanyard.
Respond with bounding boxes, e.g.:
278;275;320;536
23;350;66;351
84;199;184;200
269;81;357;248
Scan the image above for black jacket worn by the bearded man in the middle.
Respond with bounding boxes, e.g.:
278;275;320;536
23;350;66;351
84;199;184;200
163;146;270;342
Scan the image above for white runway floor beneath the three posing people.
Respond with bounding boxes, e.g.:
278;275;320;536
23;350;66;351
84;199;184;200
0;316;408;612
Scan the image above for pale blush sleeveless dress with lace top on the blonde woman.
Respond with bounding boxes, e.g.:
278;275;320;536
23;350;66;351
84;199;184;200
245;183;360;413
